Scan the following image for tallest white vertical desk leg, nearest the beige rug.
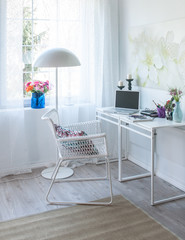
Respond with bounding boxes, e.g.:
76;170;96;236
151;130;156;206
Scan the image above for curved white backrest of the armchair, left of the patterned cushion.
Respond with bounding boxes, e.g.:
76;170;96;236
41;109;60;139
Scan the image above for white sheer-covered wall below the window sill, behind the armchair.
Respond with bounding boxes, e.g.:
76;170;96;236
0;104;95;177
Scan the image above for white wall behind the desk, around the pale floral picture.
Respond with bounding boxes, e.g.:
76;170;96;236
119;0;185;190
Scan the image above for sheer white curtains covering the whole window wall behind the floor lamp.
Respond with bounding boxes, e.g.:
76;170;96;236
0;0;119;176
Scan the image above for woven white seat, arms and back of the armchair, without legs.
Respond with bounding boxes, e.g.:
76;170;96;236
41;109;107;160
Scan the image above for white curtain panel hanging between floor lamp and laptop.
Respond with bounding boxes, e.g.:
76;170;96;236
81;0;119;107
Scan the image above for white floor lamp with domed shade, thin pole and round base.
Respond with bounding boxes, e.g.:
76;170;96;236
34;48;80;179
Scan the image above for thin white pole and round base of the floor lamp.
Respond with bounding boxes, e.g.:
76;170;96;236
41;68;74;179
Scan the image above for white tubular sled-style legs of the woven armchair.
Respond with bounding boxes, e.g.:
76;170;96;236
46;157;113;206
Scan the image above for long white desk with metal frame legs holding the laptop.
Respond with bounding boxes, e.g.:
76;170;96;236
96;108;185;205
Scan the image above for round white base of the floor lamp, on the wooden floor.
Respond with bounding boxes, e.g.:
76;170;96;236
41;167;74;179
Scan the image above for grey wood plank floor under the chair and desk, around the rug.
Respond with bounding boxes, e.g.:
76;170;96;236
0;161;185;239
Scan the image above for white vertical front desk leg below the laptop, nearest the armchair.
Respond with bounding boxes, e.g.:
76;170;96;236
118;119;122;182
